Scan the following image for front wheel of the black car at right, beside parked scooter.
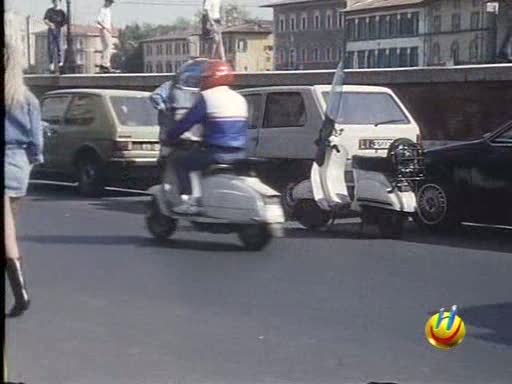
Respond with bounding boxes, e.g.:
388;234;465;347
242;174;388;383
417;182;460;230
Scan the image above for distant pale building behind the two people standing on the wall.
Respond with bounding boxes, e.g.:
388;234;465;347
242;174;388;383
35;24;119;73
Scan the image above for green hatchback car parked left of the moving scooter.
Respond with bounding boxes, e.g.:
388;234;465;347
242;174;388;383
37;89;160;197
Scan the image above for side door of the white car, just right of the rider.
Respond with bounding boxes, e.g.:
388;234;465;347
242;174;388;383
257;91;317;159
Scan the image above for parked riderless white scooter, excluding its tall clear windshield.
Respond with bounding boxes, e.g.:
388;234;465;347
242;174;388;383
292;129;423;238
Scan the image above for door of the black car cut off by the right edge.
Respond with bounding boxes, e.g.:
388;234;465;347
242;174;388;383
471;124;512;225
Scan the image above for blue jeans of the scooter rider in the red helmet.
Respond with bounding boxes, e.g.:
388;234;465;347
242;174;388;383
174;146;246;195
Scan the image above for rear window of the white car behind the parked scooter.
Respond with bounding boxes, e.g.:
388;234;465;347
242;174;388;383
322;92;409;125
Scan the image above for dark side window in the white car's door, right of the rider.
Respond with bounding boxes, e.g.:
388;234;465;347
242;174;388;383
263;92;306;128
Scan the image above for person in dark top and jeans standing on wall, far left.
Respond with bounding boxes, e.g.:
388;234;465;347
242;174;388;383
43;0;68;73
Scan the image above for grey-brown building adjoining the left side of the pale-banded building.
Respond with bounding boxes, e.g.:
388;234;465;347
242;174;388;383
264;0;345;70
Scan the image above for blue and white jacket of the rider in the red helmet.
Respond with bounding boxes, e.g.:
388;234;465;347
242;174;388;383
167;86;249;148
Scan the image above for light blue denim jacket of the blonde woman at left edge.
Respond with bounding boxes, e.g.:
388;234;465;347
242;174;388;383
5;92;43;164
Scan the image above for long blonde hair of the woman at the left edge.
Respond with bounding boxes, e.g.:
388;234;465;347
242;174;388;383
4;14;28;110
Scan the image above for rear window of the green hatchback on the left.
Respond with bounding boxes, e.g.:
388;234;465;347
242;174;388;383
110;96;158;127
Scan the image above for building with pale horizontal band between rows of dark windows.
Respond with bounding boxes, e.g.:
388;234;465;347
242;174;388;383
344;0;425;68
